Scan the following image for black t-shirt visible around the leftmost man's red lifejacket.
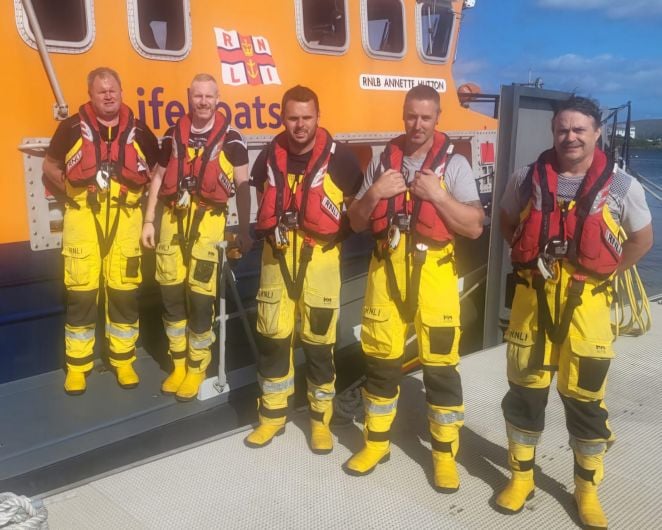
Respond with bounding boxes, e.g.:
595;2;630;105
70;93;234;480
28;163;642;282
46;114;159;168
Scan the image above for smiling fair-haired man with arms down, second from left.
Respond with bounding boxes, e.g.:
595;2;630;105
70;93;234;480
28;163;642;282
142;74;252;401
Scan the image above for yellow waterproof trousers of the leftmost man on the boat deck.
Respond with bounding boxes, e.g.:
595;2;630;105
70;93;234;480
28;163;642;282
62;180;142;372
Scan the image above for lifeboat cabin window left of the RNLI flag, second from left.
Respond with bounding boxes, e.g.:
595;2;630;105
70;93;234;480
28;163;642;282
127;0;191;61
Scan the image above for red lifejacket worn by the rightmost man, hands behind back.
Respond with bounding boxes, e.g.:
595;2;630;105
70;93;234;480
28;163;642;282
511;144;622;278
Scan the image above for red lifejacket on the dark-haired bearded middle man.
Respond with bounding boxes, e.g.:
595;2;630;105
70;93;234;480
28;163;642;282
256;127;341;240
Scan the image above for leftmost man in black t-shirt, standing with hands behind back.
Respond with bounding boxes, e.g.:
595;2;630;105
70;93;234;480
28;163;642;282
43;68;159;394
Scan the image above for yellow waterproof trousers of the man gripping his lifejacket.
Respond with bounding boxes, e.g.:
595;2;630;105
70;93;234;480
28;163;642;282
361;236;464;448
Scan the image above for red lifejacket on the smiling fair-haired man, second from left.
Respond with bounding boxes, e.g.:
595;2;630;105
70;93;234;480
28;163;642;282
159;112;234;204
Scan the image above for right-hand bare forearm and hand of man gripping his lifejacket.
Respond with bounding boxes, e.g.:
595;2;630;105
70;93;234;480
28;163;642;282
410;169;485;239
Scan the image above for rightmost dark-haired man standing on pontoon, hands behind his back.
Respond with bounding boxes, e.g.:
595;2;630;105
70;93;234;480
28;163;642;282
496;96;653;528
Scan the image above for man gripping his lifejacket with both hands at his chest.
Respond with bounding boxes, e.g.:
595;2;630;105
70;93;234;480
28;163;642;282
345;85;483;492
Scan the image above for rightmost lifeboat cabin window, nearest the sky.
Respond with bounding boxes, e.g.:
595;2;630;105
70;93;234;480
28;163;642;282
416;0;455;63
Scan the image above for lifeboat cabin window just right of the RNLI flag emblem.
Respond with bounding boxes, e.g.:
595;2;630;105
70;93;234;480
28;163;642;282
295;0;349;55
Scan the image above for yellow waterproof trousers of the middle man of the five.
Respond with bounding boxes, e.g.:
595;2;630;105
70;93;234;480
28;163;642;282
257;232;340;424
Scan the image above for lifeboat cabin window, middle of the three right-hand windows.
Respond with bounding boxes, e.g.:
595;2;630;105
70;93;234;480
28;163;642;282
361;0;407;59
